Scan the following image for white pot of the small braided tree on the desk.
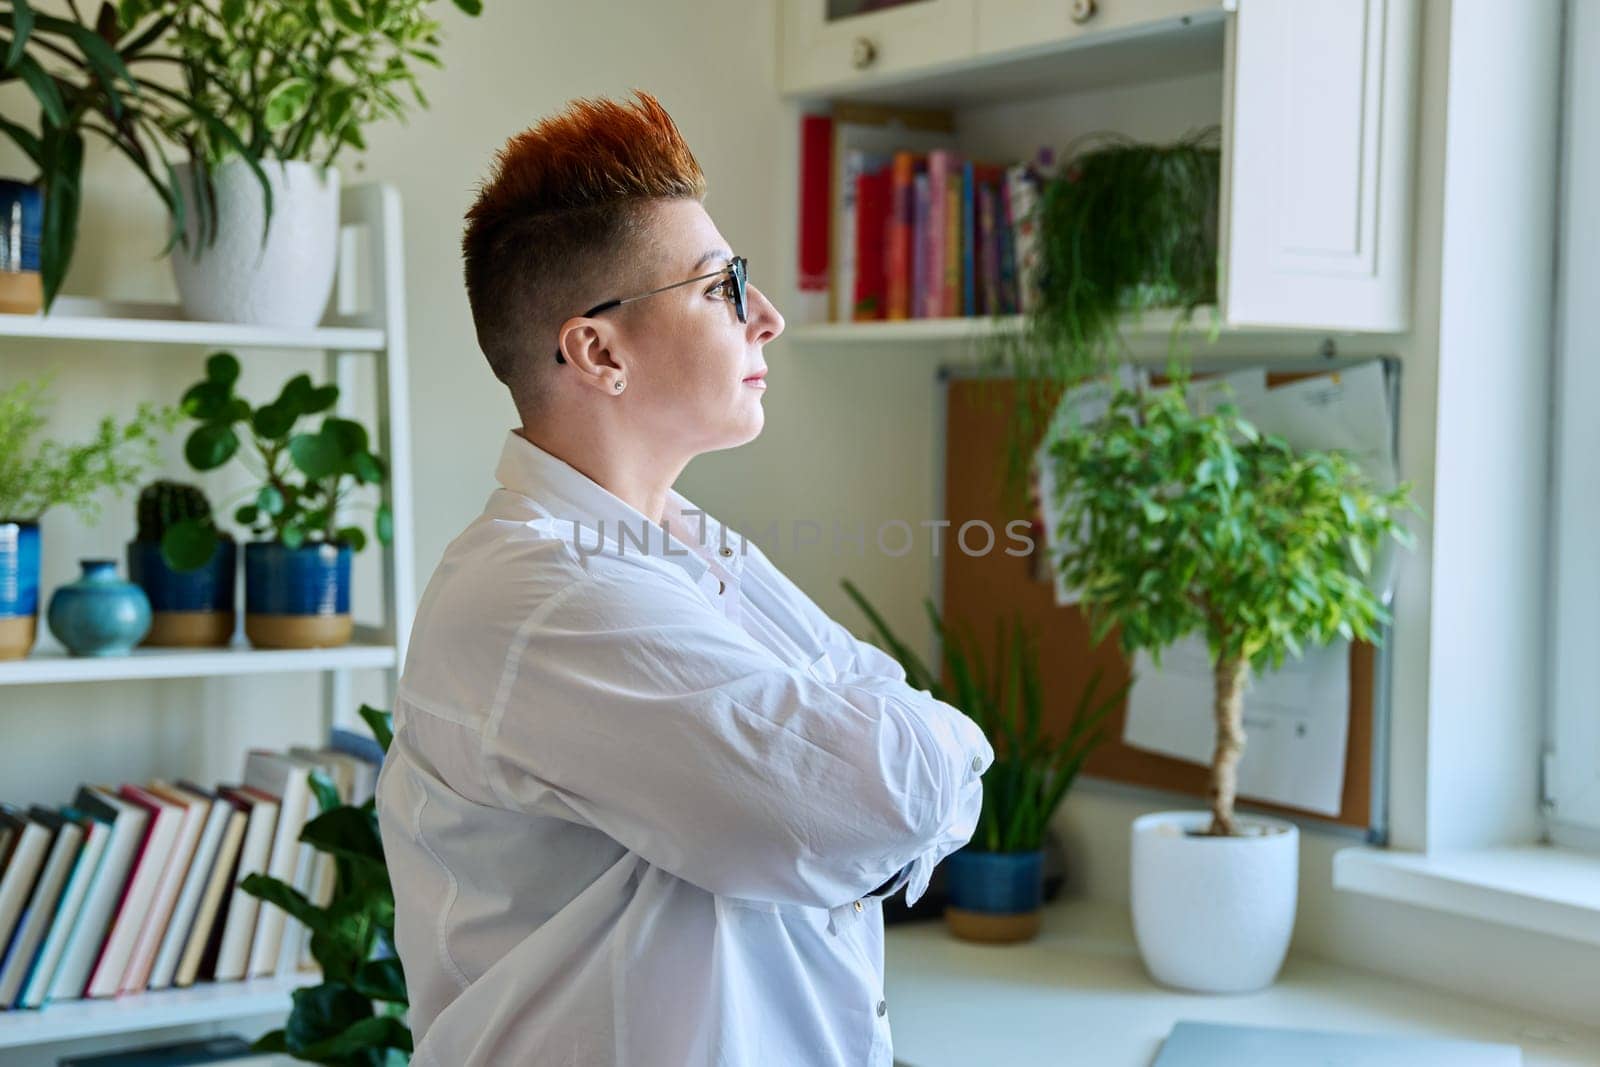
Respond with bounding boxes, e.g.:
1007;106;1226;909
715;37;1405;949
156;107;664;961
1131;811;1299;993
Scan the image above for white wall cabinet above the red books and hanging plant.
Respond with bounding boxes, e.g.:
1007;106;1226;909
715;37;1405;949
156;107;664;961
779;0;1421;333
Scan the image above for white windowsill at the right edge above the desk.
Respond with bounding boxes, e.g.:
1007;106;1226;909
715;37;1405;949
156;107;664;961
1333;845;1600;945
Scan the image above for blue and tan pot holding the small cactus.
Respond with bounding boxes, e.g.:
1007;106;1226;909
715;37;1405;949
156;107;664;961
128;537;238;648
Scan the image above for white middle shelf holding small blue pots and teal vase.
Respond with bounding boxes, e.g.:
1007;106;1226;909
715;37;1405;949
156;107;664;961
0;641;395;685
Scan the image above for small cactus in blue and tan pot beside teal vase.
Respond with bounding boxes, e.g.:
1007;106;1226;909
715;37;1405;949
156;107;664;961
128;482;237;648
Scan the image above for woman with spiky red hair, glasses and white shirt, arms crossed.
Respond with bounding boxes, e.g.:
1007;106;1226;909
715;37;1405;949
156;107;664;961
378;93;994;1067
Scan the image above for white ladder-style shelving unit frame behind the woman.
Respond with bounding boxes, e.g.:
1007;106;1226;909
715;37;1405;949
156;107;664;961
0;184;416;1049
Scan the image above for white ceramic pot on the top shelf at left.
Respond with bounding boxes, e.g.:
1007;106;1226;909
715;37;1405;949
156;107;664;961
171;158;339;328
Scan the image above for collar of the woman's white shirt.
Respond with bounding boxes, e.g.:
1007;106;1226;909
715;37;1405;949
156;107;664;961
494;430;746;582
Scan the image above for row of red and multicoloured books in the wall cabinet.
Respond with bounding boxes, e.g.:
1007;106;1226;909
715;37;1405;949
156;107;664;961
800;112;1051;322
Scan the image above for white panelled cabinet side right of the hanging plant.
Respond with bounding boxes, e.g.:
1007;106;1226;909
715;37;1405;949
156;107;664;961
1221;0;1421;333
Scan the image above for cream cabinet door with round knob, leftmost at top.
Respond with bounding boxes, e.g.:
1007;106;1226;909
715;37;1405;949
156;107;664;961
779;0;974;93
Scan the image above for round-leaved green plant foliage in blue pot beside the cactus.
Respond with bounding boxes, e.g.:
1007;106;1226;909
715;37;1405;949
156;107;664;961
163;352;394;566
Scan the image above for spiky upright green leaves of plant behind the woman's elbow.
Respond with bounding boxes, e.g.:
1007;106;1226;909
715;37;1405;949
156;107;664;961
843;581;1126;853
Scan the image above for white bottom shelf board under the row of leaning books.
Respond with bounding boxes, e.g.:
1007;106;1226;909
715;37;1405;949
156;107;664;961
0;971;322;1048
